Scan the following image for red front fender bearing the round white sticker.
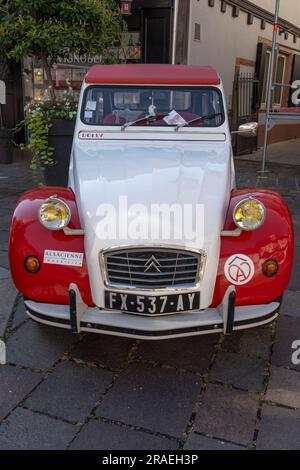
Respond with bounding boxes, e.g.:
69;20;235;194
212;189;294;306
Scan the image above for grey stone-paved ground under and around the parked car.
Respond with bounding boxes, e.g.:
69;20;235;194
0;161;300;450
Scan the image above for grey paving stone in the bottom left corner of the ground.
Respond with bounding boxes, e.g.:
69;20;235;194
0;408;78;450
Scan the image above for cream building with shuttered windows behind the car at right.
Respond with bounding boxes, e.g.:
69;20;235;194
187;0;300;151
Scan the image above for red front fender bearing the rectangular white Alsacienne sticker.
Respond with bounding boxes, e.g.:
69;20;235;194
9;187;93;306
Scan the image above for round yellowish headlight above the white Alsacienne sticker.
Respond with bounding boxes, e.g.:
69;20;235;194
39;197;71;230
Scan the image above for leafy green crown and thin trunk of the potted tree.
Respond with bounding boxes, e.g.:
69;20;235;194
0;0;123;101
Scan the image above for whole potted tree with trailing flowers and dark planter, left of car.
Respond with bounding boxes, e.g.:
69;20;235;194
0;0;124;186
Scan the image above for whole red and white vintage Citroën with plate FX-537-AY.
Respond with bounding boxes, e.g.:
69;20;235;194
9;65;294;339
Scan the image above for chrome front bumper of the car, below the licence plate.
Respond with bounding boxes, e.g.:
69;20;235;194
25;291;280;339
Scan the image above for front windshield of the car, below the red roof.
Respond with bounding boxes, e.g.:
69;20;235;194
81;86;224;130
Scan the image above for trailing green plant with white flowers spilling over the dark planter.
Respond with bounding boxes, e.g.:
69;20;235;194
18;96;77;174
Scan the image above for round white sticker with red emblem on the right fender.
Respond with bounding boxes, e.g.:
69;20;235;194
224;254;255;286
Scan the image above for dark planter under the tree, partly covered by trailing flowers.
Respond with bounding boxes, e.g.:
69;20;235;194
43;119;75;187
